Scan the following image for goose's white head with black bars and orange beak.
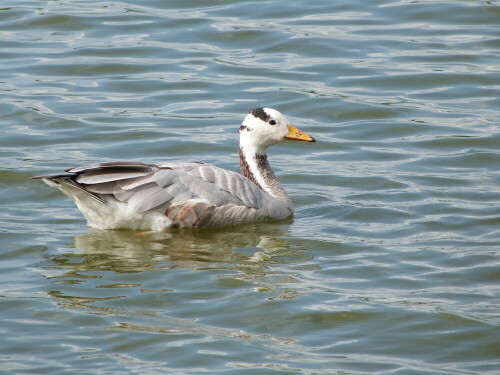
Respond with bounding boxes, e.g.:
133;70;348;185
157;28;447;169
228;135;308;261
240;108;314;154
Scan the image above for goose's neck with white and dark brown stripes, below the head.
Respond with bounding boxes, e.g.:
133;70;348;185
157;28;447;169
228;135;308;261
238;143;291;206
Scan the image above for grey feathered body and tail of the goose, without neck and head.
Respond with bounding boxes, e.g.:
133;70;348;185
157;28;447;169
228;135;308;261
33;161;293;230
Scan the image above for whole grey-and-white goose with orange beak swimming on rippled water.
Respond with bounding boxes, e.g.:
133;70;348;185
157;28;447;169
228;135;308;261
31;108;315;231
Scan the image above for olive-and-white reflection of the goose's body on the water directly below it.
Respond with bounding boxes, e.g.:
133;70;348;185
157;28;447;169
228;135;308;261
48;222;306;273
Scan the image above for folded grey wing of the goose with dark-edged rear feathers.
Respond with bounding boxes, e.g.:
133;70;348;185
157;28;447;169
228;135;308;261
48;161;270;212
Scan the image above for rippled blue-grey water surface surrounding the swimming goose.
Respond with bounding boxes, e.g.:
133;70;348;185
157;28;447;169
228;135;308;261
0;0;500;374
